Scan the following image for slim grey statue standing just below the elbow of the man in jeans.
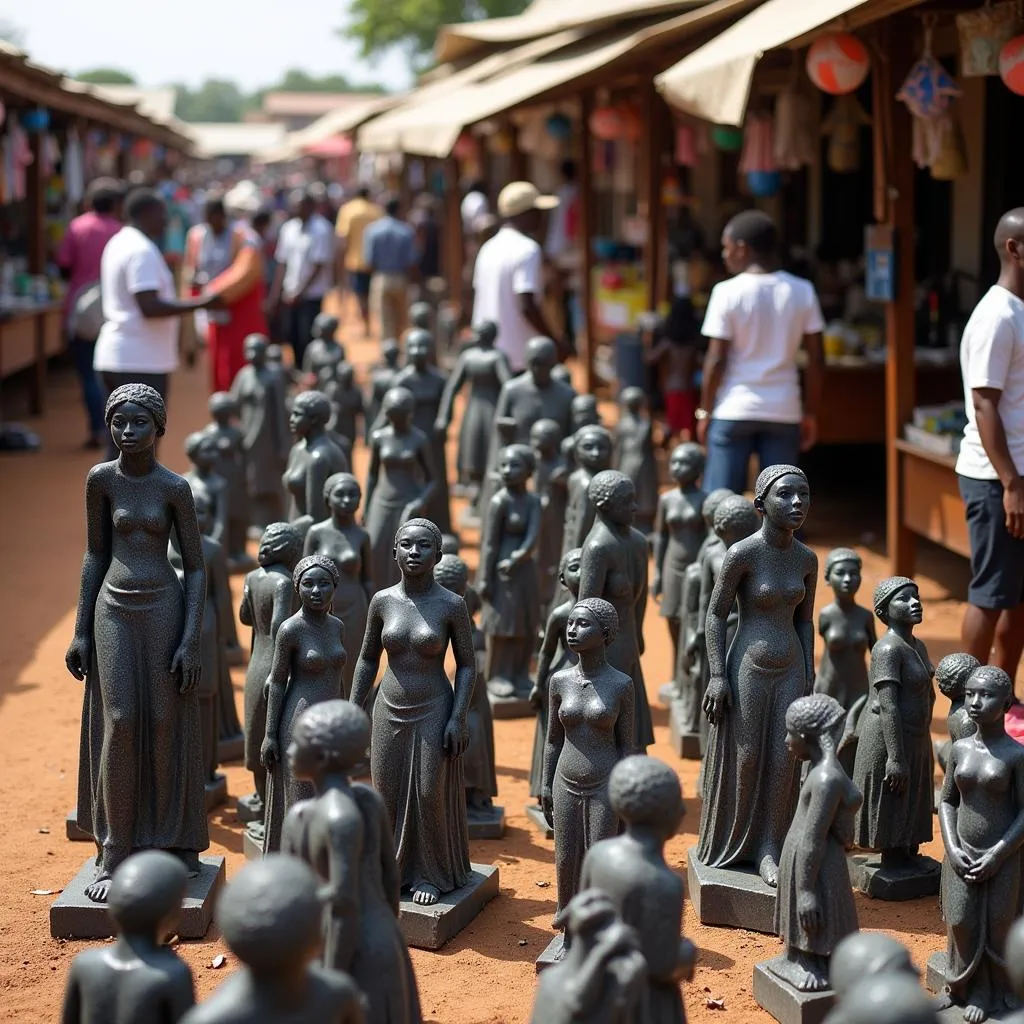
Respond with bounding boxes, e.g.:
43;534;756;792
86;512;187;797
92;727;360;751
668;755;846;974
650;444;708;692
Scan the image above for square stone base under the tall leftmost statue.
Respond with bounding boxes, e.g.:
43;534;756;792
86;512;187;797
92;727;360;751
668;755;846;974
50;857;226;939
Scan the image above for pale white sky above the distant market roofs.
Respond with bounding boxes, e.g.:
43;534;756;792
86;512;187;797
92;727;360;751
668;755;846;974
0;0;411;91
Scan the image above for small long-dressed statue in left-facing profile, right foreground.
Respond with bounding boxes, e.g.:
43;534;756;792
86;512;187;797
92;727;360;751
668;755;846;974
765;693;860;992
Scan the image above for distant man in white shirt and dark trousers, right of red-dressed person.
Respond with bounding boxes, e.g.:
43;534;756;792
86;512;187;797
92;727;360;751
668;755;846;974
270;190;334;367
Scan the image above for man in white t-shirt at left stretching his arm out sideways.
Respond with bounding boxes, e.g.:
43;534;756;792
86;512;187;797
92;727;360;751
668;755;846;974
92;188;220;458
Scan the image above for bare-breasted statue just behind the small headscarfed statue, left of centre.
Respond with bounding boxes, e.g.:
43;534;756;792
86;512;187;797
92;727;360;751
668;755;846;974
305;473;374;699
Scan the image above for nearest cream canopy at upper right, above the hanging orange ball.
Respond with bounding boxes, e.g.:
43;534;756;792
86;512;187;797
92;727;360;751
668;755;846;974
654;0;922;125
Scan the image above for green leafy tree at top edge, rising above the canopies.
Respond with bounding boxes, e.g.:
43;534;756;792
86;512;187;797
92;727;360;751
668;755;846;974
341;0;527;67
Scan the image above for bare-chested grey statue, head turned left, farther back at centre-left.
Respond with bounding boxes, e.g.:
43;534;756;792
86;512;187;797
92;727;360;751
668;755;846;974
282;391;348;534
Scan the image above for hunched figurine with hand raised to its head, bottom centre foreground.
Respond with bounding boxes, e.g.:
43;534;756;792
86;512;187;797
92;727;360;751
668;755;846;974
529;889;647;1024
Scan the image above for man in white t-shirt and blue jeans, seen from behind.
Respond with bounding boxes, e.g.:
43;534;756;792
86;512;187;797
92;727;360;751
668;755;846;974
696;210;824;494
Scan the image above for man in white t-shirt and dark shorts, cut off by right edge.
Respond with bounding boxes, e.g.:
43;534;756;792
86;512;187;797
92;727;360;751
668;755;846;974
956;207;1024;704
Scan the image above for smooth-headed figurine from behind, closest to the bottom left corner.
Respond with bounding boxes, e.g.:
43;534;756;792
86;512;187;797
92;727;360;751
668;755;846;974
60;850;196;1024
